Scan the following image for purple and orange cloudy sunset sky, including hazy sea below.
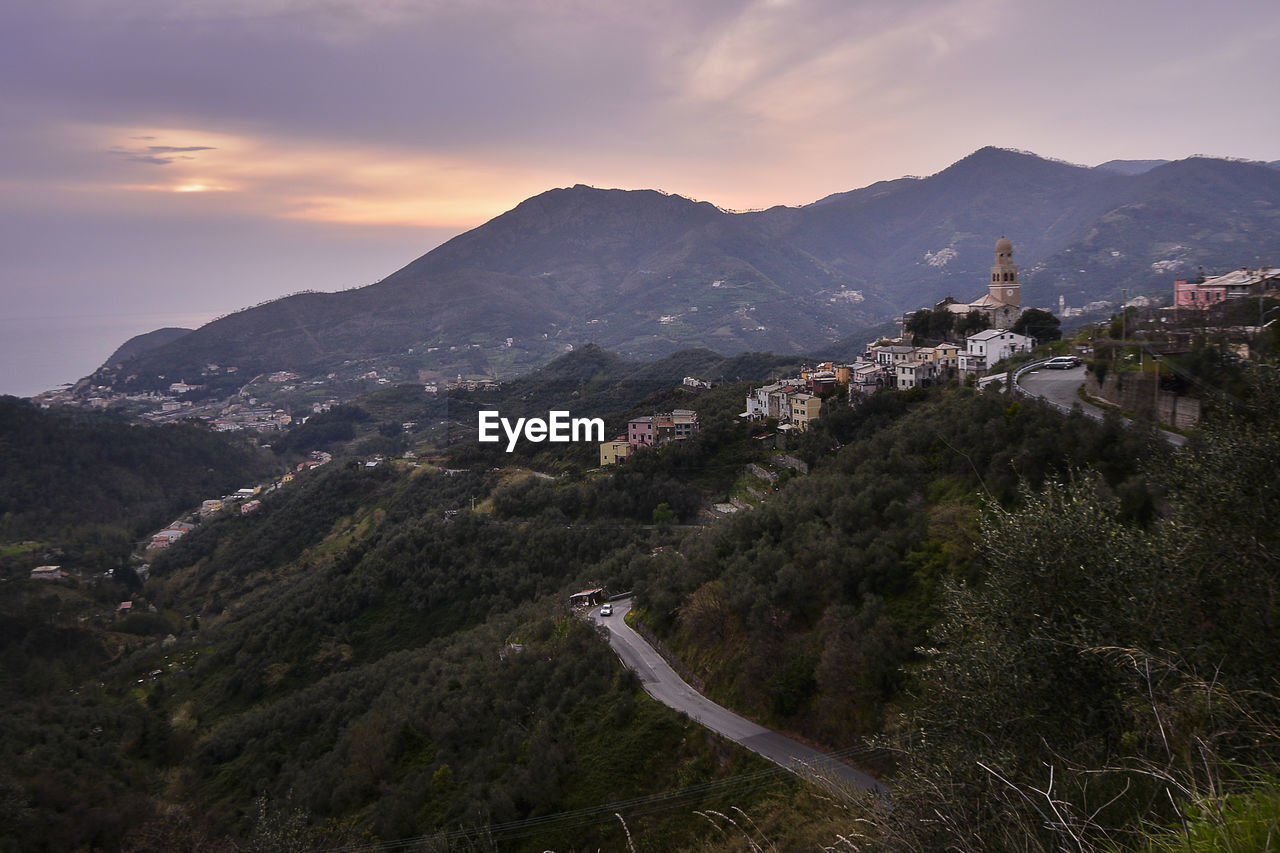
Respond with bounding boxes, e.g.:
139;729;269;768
0;0;1280;394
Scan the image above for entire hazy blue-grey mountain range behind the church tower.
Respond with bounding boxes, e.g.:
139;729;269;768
99;147;1280;383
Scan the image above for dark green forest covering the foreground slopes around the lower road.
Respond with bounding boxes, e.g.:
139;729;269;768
0;353;1280;850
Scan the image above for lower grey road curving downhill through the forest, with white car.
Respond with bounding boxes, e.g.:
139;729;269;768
588;598;888;793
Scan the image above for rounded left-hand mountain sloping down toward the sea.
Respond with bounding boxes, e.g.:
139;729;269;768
107;186;860;378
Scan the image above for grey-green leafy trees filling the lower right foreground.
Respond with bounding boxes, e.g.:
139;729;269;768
893;371;1280;850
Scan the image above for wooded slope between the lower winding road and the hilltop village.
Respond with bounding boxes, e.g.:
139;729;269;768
640;389;1166;743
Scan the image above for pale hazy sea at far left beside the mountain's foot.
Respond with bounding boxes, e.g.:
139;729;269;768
0;314;216;397
